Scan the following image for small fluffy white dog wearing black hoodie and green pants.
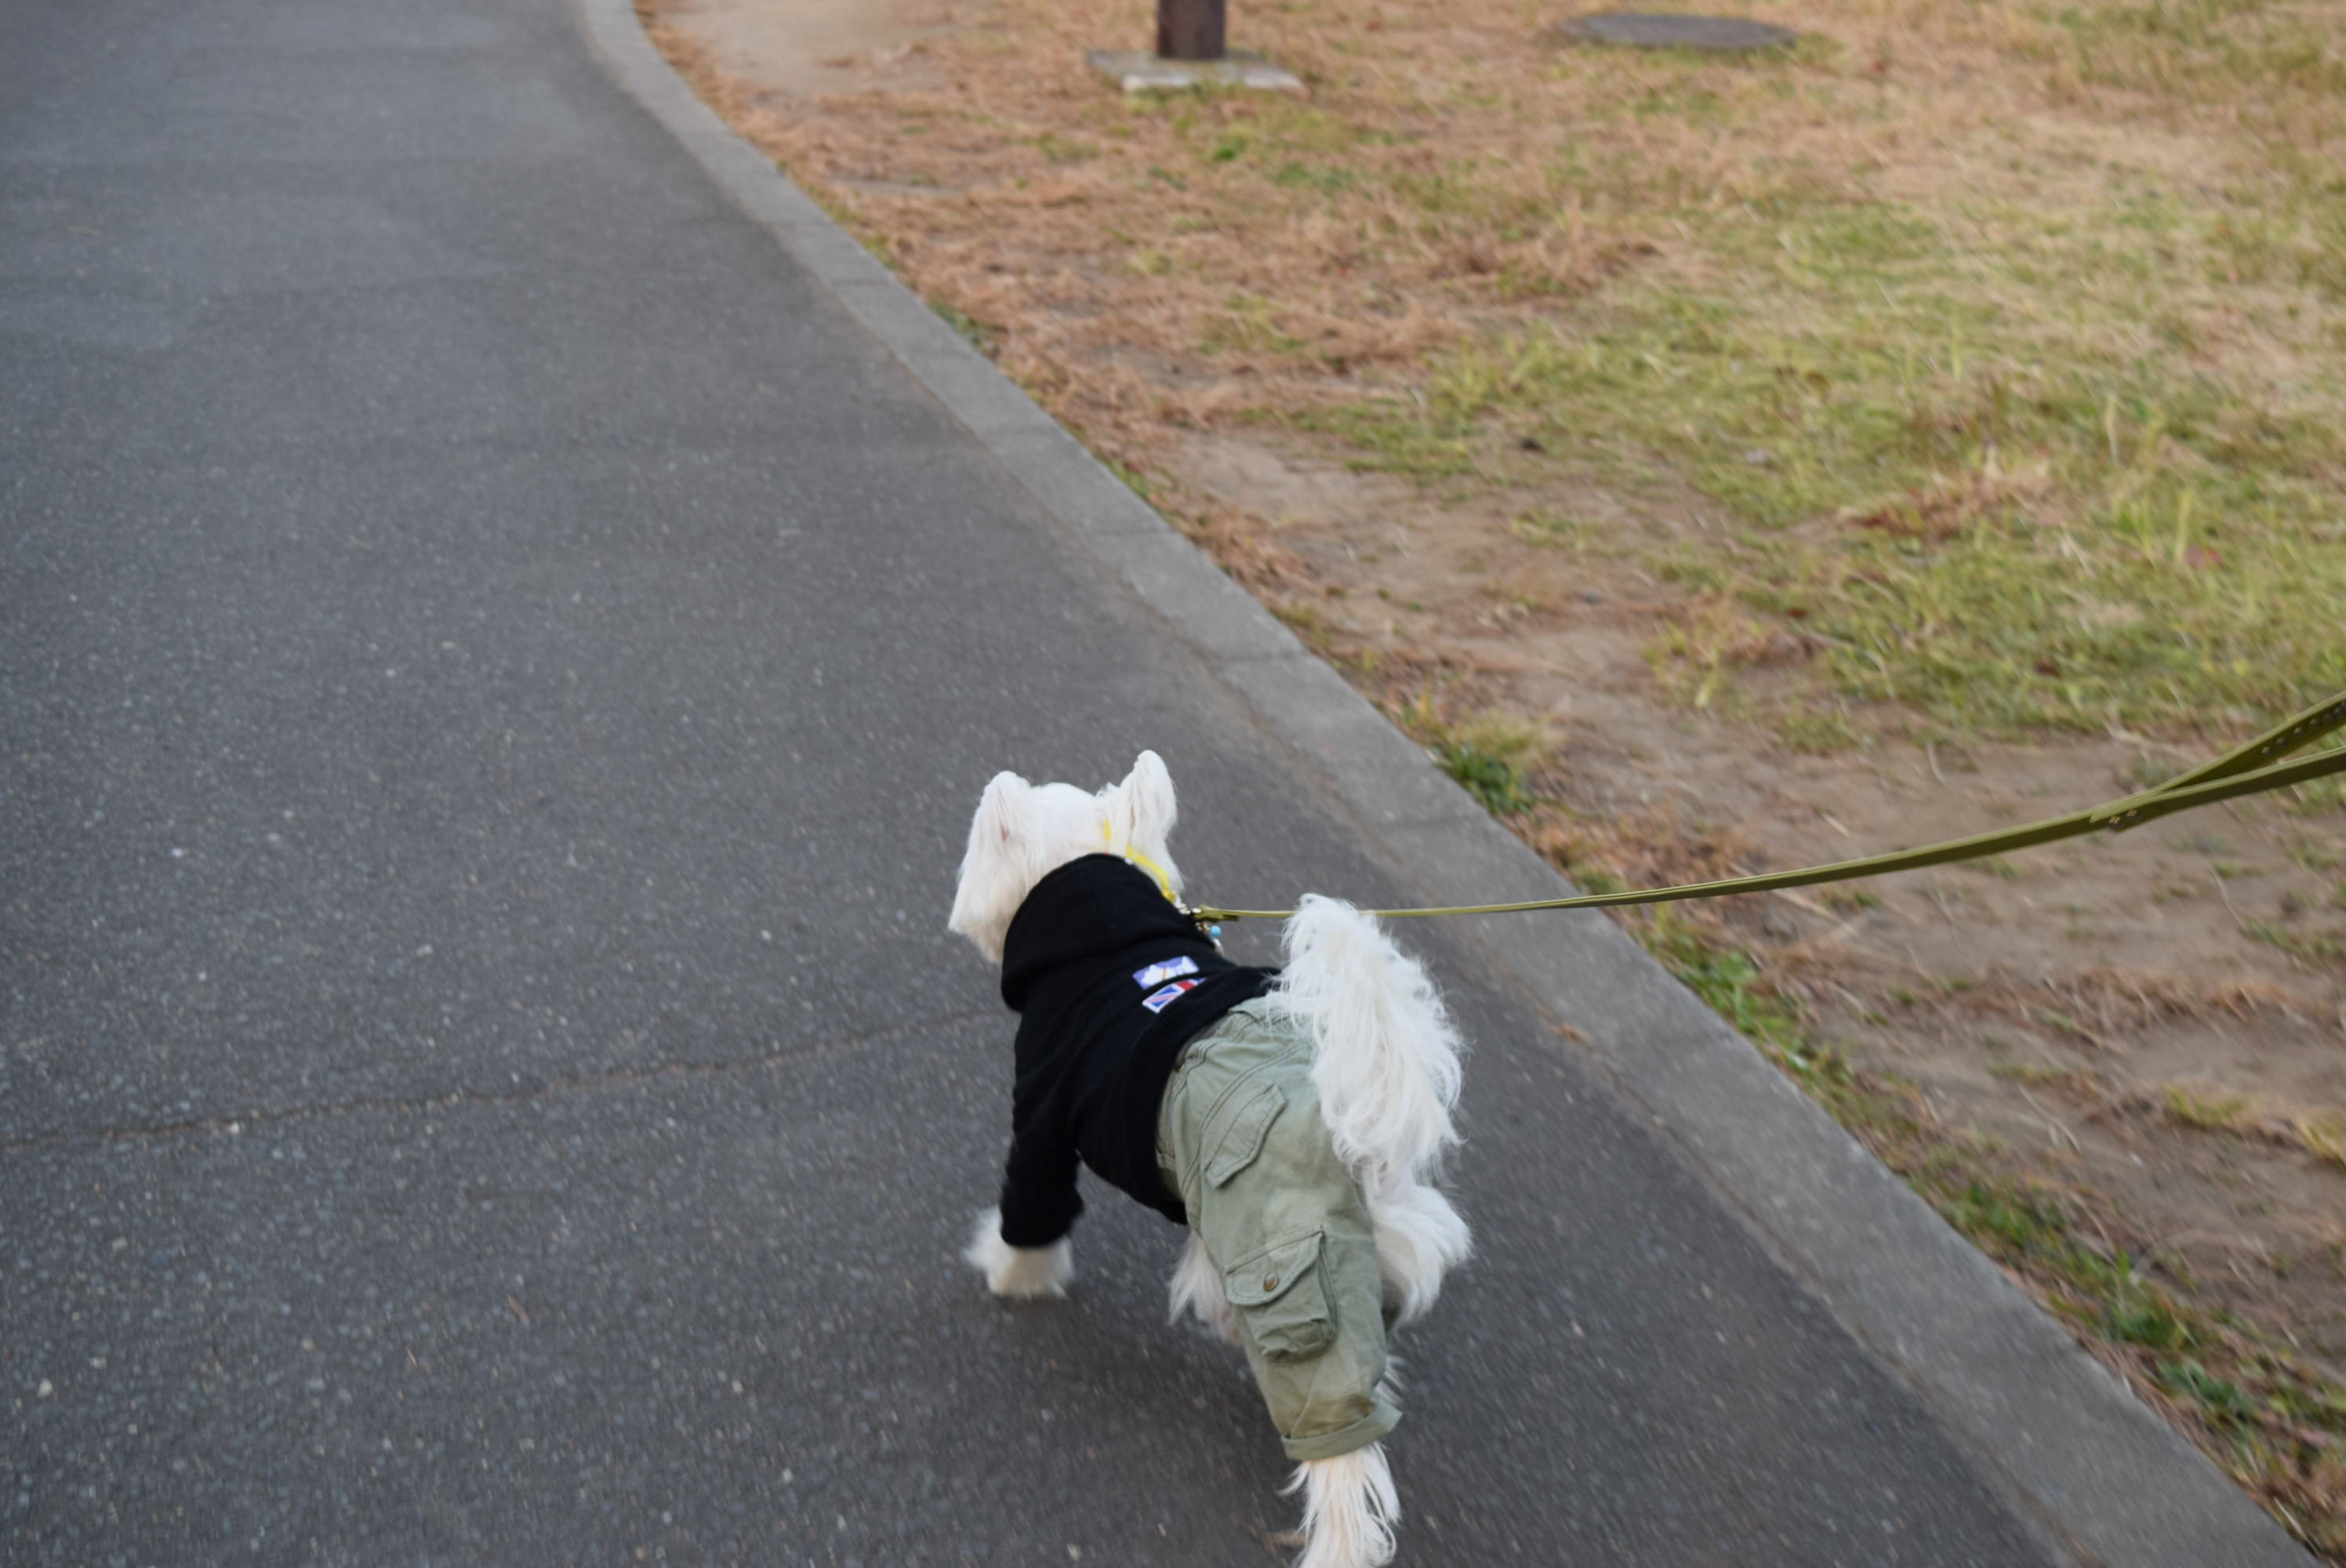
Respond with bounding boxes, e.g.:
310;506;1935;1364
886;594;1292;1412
950;751;1469;1568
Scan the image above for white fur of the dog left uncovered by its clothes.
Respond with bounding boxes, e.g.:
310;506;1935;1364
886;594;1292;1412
948;751;1469;1568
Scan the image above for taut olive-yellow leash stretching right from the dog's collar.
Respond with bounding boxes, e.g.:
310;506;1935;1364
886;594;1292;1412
1191;692;2346;925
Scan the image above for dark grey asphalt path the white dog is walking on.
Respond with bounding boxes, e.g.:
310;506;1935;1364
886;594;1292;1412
0;0;2053;1568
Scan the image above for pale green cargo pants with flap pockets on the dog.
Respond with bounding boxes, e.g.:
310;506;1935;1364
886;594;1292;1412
1157;997;1400;1460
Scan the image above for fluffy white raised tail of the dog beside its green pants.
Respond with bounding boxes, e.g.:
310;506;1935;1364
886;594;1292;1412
1272;895;1469;1322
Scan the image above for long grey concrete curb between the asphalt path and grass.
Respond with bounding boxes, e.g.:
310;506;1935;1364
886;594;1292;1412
575;0;2313;1568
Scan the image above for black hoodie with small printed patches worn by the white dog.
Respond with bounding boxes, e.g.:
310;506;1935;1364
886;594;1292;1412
1002;855;1274;1247
